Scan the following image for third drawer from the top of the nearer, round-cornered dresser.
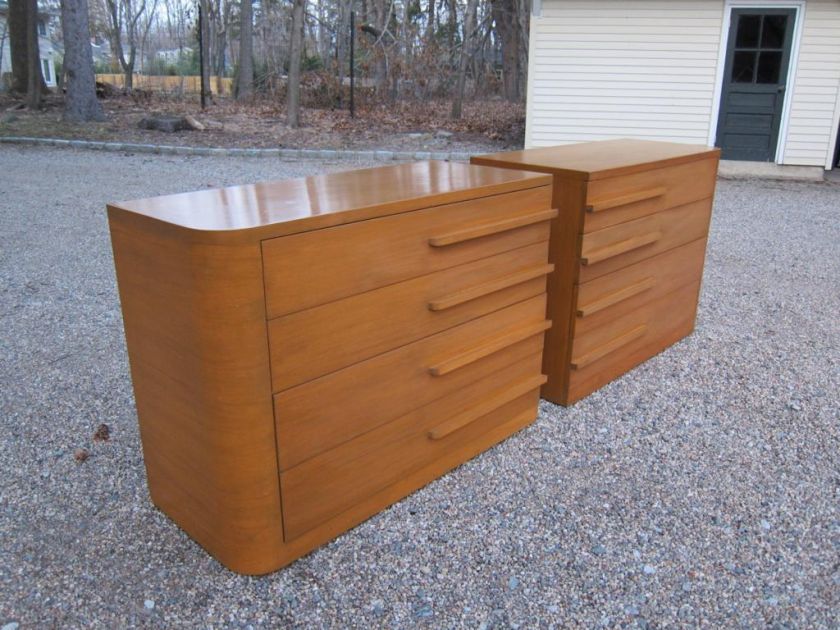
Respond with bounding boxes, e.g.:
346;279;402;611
274;294;548;470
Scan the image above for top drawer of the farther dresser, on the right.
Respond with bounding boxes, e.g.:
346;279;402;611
583;157;718;232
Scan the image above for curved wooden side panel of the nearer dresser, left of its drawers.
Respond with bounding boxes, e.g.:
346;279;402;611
109;214;282;574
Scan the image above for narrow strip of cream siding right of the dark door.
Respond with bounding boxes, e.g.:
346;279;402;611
783;0;840;167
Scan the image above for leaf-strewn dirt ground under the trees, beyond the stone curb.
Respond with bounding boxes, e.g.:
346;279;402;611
0;92;525;152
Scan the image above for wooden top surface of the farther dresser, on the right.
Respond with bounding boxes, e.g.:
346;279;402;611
471;138;720;180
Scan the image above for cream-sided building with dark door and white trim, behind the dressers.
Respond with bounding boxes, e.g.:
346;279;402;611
525;0;840;169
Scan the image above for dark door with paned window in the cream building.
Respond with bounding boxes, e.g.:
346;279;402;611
715;9;796;162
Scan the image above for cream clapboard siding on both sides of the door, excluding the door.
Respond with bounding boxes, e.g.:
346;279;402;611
525;0;840;166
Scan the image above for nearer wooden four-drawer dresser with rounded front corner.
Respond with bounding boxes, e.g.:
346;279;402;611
108;162;557;574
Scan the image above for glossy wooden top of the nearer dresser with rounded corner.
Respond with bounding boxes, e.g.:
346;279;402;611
108;161;551;240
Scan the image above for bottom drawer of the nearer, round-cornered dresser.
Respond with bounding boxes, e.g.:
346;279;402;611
280;353;545;540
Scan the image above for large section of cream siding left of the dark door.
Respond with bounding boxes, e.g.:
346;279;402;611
526;0;723;146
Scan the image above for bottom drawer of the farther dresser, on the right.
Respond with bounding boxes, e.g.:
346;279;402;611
569;281;700;403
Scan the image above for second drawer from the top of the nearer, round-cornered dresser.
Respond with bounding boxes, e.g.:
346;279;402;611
268;241;552;391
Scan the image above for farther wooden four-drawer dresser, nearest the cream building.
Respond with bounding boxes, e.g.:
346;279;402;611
472;140;719;405
